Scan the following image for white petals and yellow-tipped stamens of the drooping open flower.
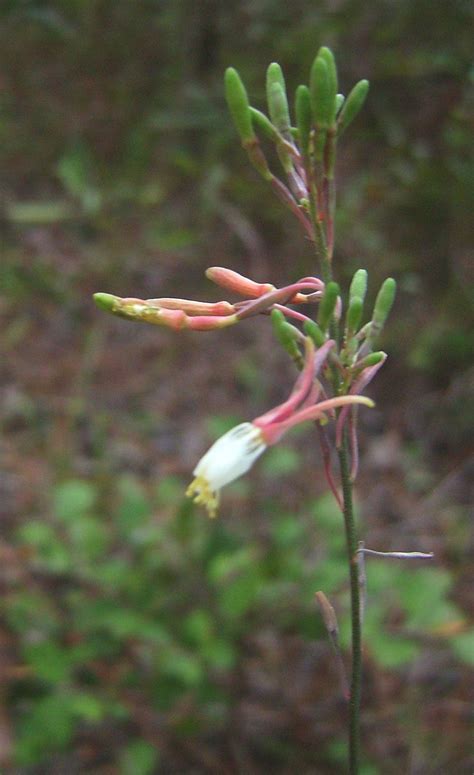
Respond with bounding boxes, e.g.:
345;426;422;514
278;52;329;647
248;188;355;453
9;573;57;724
186;422;267;517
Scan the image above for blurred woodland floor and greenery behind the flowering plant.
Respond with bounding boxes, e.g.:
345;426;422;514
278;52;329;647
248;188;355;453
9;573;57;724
0;0;474;775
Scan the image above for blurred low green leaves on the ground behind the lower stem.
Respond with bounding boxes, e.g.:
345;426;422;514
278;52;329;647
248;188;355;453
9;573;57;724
5;472;473;773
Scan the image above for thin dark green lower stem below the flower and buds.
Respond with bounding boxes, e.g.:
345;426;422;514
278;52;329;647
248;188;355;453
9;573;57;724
338;434;362;775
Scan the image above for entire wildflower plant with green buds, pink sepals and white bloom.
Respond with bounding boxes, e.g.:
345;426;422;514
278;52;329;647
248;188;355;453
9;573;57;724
94;47;431;775
